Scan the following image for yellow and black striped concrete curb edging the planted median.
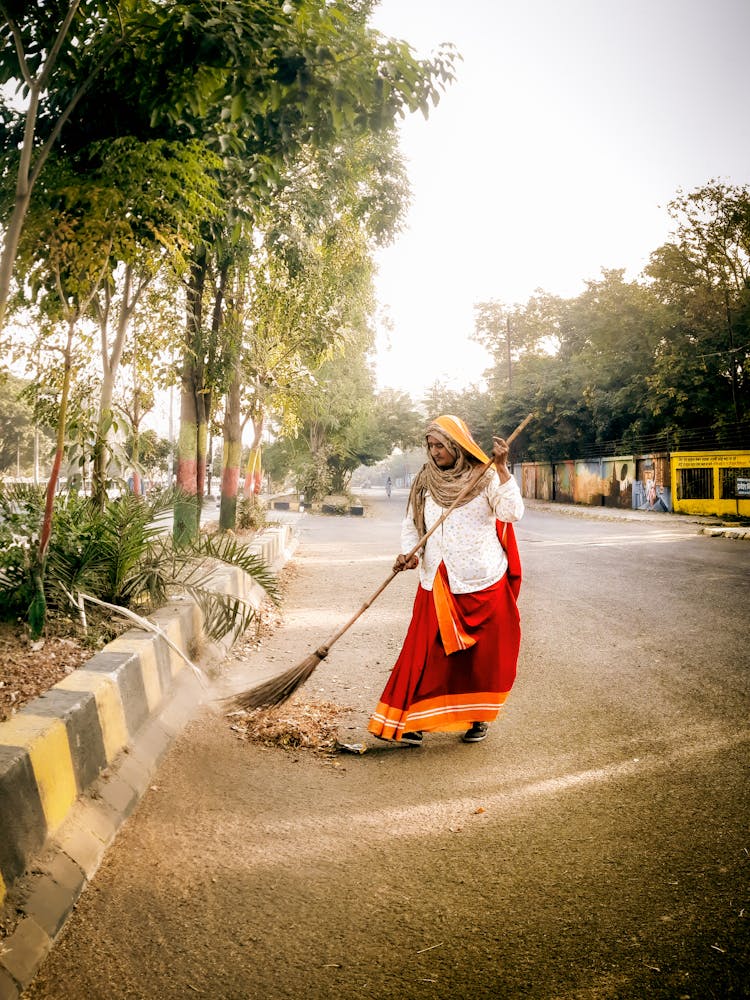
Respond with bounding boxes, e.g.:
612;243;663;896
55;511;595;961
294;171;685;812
0;525;294;1000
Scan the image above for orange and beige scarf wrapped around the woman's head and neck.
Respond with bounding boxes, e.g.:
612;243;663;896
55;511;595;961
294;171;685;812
409;414;489;537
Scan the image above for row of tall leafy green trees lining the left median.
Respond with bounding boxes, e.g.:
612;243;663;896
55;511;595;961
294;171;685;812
0;0;455;632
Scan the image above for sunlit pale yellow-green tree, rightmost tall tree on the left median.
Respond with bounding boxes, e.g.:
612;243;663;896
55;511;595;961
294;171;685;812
220;132;407;527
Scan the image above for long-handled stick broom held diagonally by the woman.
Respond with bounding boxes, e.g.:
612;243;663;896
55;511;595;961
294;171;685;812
223;413;533;712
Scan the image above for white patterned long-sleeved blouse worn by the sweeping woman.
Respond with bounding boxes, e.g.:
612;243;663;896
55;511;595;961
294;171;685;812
401;469;524;594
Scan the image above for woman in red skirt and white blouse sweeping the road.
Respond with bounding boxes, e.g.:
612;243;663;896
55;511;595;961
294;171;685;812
368;415;523;745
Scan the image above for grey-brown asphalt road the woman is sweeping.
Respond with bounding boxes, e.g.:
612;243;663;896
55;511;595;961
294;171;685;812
24;492;750;1000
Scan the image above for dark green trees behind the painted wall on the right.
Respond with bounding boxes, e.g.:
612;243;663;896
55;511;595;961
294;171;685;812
472;182;750;459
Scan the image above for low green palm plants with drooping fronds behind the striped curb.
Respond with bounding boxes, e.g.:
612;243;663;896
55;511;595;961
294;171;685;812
0;486;277;639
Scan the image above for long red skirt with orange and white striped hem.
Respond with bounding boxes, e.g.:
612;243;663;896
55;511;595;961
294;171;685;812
367;564;521;740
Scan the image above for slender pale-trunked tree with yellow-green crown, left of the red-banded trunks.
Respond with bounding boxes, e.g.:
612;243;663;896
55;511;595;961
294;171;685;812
13;138;219;507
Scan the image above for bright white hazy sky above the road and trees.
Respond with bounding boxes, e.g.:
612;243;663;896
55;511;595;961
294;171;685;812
372;0;750;399
